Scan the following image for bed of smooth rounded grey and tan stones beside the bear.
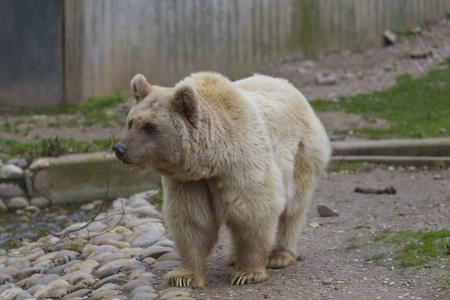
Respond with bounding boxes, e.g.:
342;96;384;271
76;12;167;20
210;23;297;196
0;191;194;300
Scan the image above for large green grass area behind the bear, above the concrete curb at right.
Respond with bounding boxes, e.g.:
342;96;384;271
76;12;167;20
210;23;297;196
311;68;450;139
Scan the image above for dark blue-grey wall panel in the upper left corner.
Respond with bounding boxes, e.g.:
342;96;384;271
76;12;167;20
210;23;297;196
0;0;64;109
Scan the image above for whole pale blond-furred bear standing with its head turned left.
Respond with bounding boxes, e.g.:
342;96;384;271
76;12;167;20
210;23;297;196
113;72;331;287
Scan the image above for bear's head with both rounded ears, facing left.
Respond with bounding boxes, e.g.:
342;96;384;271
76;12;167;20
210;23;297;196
113;74;200;176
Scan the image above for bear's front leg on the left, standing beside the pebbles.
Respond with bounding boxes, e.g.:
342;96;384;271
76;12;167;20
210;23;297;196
163;178;219;287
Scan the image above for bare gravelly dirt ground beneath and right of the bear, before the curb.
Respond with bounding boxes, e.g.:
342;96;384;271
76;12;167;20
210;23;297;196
162;169;450;300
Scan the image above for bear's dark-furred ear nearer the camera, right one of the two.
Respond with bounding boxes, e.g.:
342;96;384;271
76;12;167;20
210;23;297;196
172;85;199;128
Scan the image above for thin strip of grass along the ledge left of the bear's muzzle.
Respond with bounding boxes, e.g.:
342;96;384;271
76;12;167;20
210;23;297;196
0;138;119;158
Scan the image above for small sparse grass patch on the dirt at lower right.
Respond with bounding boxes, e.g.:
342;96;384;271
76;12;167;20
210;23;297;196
373;230;450;267
